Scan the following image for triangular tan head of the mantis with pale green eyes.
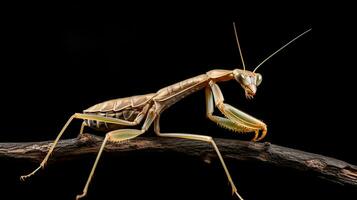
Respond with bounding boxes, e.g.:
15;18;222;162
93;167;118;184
233;69;263;99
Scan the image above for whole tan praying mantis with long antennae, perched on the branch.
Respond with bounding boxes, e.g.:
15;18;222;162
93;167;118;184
20;23;312;200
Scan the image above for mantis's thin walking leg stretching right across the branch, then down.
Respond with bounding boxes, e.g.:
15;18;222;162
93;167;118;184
154;115;243;200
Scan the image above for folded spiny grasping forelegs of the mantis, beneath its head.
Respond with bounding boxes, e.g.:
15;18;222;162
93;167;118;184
206;81;267;141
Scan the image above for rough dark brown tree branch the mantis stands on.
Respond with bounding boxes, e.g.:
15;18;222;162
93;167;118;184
0;134;357;187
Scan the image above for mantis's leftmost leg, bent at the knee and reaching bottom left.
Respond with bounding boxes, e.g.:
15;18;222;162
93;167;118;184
20;113;143;180
